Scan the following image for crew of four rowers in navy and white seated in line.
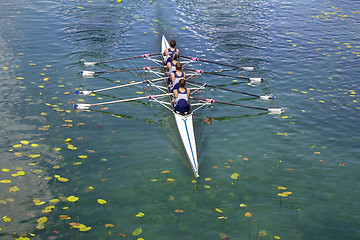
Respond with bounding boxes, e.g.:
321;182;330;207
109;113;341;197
163;40;190;113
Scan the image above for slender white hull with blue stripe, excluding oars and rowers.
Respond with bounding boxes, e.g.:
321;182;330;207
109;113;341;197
161;36;199;177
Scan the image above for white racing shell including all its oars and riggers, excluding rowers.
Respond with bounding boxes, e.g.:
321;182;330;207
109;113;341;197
73;36;283;178
